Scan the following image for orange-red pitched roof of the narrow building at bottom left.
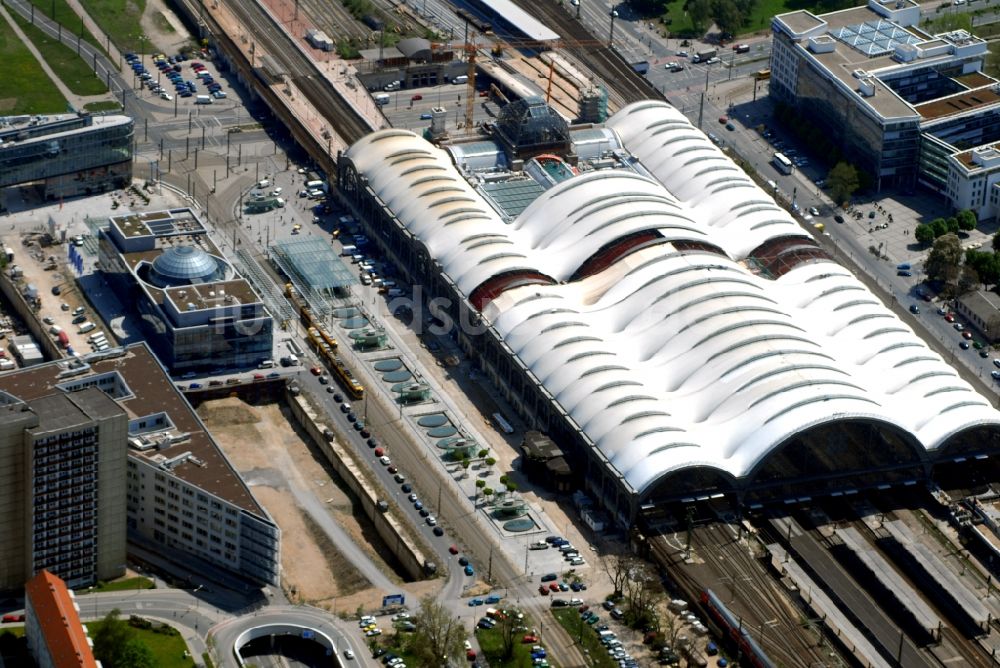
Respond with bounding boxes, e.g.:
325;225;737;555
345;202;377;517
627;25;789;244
24;570;97;668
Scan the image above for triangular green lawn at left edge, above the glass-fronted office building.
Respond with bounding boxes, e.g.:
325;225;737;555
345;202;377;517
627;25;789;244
0;14;66;116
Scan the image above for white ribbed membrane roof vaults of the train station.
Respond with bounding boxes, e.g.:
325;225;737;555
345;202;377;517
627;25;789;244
347;111;1000;494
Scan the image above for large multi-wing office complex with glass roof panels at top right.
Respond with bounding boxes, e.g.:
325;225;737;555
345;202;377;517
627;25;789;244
770;0;1000;219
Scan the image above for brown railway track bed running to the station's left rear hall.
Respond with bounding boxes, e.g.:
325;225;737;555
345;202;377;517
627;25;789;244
229;0;372;145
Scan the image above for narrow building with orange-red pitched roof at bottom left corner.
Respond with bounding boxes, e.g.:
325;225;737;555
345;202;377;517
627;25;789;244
24;570;101;668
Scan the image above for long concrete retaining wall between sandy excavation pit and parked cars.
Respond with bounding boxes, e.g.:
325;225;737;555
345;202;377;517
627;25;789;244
286;393;427;580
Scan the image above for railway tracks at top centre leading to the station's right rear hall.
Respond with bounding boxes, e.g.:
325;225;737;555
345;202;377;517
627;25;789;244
513;0;663;105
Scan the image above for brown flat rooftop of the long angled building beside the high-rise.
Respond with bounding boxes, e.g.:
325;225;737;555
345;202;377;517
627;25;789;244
0;343;267;517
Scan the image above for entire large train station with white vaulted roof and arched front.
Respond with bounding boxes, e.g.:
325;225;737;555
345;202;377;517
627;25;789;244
338;101;1000;526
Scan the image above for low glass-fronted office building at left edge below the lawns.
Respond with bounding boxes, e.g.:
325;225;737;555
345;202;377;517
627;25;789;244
0;112;135;200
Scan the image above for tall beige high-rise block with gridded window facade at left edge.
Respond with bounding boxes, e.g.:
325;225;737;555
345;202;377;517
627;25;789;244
0;384;128;589
